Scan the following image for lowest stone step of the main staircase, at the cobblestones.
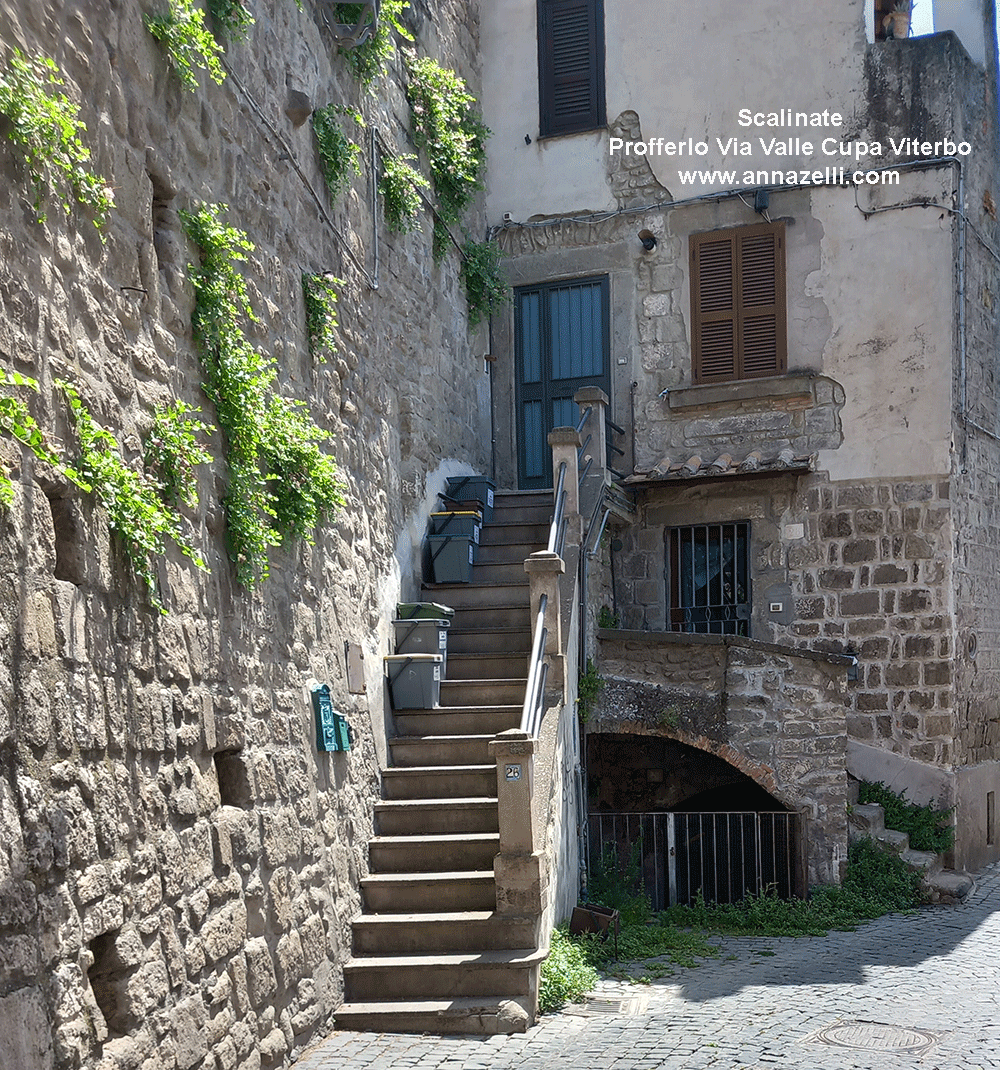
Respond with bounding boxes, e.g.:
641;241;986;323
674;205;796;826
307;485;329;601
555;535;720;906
335;996;528;1037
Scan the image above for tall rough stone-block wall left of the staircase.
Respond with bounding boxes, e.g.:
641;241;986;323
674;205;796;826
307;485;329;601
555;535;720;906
0;0;490;1070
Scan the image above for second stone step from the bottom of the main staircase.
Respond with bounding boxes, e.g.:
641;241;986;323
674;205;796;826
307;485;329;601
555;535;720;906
343;948;545;1003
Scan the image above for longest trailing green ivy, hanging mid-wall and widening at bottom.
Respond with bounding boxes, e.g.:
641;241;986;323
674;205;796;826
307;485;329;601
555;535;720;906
180;204;343;587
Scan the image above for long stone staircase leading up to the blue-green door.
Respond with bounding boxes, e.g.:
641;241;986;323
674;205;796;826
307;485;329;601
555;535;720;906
336;492;552;1034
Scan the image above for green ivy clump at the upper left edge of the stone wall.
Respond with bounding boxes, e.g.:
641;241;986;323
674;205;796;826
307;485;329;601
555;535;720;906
0;48;114;229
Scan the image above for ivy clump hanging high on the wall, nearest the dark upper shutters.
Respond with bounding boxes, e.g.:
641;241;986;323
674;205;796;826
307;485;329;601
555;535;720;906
406;56;490;245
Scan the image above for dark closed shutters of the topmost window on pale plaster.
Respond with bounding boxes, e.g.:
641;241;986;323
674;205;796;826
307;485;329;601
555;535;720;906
538;0;605;137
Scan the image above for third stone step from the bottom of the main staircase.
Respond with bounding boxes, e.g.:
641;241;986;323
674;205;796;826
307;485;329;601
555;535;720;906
352;911;535;957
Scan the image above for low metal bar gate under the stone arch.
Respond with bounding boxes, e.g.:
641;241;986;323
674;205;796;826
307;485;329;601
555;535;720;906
589;811;805;911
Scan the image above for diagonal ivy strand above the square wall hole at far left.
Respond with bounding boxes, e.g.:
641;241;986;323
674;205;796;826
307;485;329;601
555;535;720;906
56;380;206;613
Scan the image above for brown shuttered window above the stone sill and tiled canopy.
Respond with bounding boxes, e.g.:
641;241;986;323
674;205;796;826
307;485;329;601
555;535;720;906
691;223;787;383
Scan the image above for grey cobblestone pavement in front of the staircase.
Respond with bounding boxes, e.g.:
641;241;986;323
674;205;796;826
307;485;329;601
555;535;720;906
294;866;1000;1070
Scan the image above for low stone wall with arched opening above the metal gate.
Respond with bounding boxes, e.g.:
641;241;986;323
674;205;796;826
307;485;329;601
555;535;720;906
587;630;847;884
